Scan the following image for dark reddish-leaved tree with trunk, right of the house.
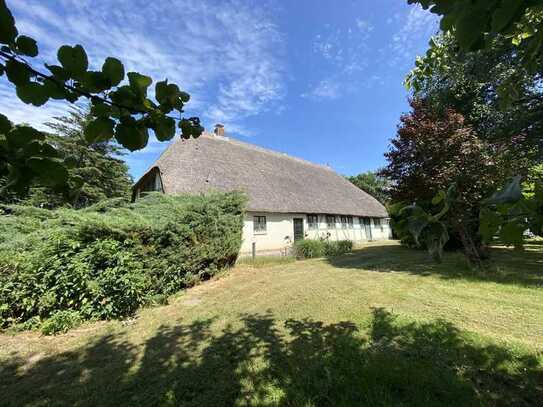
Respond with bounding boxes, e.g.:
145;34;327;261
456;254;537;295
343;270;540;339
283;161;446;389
380;99;506;263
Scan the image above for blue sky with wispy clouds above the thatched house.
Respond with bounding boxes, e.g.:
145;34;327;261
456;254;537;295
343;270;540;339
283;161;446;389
0;0;437;178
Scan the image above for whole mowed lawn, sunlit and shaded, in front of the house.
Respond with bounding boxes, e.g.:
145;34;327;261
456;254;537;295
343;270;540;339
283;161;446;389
0;241;543;406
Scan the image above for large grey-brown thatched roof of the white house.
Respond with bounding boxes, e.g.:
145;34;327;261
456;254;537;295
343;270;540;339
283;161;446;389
135;133;387;217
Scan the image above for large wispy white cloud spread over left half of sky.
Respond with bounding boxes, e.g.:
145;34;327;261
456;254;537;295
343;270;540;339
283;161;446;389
0;0;285;140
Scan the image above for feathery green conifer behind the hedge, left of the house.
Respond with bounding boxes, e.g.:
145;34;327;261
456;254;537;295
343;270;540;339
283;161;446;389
10;107;132;208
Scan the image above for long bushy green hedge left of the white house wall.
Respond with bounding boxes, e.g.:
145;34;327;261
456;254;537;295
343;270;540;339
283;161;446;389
0;193;245;327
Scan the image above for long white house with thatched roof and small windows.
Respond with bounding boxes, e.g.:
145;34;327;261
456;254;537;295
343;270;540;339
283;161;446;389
134;125;391;255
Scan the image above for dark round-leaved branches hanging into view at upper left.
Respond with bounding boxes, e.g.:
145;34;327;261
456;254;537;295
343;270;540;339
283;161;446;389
0;0;203;198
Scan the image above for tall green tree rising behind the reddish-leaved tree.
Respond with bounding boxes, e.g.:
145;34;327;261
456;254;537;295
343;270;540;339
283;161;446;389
407;34;543;169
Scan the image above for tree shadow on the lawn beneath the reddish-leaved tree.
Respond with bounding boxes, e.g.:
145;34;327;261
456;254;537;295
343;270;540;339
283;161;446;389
326;242;543;288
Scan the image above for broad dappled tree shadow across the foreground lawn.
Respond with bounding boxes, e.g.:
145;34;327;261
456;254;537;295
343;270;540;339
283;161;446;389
0;309;543;406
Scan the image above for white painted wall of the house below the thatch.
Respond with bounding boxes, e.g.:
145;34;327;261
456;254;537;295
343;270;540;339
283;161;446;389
240;212;392;255
